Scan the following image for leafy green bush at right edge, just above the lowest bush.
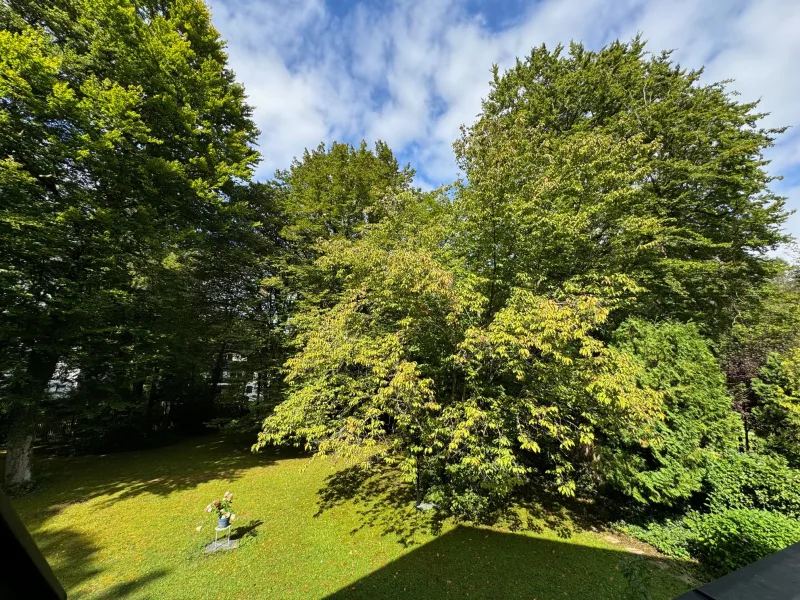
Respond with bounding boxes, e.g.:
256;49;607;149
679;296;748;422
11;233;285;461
706;452;800;518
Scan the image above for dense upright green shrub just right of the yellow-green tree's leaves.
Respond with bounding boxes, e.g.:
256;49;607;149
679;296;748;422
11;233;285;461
599;319;739;506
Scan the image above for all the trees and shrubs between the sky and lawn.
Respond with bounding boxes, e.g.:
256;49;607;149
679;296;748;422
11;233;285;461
0;8;800;569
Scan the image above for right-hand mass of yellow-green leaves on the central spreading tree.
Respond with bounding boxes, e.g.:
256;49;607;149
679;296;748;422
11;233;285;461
447;279;663;495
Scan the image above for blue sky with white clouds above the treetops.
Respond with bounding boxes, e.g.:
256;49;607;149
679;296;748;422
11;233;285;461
211;0;800;237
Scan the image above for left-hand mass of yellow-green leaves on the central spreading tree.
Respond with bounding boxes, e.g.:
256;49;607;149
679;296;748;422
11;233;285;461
262;219;457;457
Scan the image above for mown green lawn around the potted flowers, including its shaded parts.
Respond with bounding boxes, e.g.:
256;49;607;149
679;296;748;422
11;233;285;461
7;438;688;600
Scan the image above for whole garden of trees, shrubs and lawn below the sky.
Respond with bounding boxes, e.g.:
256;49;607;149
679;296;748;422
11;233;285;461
0;0;800;600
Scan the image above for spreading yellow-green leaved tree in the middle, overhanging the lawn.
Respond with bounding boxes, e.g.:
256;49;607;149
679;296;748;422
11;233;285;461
256;192;660;514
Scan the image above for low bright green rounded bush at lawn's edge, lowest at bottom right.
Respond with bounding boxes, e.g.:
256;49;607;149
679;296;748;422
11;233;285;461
684;509;800;576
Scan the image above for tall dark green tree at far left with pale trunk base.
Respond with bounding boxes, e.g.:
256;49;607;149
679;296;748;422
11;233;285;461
0;0;257;484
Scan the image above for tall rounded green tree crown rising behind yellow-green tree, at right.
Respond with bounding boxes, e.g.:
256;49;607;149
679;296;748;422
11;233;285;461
455;37;786;335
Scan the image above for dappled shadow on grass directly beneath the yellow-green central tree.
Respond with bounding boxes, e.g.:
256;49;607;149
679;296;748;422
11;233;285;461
314;464;445;546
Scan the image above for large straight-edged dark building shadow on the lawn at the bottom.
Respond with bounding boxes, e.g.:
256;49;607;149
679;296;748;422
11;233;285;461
327;526;688;600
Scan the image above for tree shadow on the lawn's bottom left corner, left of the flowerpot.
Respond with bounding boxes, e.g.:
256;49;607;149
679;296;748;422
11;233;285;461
32;527;167;600
